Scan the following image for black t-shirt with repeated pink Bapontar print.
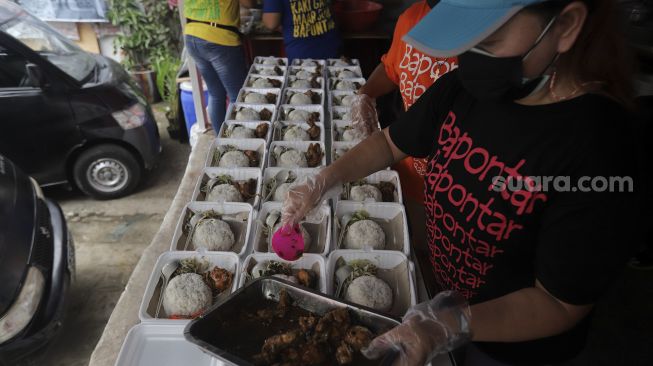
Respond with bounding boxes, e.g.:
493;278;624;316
390;71;639;364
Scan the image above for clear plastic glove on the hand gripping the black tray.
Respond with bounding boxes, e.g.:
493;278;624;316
362;291;471;366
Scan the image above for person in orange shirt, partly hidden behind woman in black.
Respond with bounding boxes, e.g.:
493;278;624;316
352;0;458;292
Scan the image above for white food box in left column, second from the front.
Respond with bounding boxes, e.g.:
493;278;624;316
170;202;254;257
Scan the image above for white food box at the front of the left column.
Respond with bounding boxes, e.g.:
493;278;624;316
138;252;240;324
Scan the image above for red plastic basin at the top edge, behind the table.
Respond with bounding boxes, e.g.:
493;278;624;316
333;0;383;32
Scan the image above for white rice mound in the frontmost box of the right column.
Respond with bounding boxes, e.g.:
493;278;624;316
345;276;393;311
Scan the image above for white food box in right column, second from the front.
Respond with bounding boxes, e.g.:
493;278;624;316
332;201;410;255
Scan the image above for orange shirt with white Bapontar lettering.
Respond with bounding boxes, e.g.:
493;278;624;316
381;1;458;202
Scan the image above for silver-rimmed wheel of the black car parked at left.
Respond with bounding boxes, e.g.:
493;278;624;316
73;144;141;199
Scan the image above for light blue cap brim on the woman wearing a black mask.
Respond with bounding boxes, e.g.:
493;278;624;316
403;2;524;57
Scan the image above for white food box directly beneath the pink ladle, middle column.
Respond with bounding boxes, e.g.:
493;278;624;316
252;202;331;256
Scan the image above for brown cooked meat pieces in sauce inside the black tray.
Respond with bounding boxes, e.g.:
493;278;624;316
253;290;374;366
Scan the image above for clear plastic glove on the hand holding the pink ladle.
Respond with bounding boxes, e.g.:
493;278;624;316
281;171;342;227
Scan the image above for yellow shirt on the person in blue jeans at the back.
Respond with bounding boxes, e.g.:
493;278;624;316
184;0;240;46
